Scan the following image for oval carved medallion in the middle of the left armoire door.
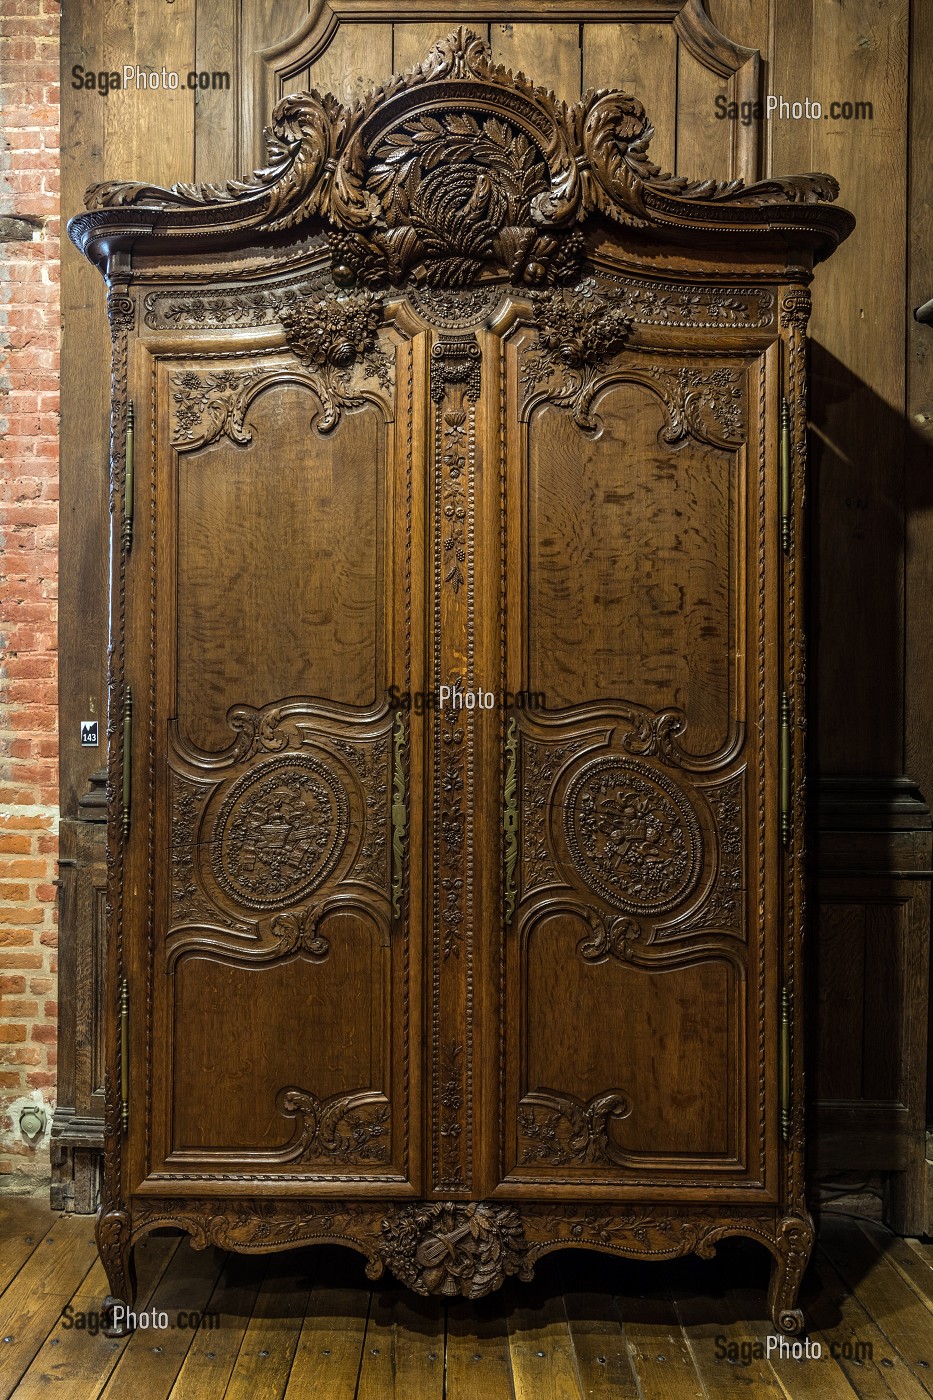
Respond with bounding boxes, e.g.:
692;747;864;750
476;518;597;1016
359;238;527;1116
212;753;349;909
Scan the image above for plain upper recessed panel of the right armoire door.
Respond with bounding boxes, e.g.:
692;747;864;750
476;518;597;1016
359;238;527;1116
528;384;735;753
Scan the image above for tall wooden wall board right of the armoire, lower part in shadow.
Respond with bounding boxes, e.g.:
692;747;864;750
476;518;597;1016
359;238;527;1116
801;0;908;774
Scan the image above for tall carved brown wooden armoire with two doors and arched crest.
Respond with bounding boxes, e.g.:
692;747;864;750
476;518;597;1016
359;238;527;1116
70;31;852;1331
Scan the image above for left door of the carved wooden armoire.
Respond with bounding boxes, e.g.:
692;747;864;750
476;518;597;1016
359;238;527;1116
120;315;422;1196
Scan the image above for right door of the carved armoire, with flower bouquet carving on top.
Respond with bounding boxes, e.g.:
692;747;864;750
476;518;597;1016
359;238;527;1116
499;287;780;1200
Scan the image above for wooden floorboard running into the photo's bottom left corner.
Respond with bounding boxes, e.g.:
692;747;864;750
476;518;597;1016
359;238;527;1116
0;1215;97;1400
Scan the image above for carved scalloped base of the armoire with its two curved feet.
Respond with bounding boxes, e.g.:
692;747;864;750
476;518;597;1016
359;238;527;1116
121;1198;813;1334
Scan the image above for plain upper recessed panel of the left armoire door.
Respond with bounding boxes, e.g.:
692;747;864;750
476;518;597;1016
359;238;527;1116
177;386;384;750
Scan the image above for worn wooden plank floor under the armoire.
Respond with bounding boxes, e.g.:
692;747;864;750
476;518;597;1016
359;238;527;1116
0;1197;933;1400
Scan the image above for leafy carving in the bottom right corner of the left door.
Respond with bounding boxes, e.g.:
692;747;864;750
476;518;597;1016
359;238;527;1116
276;1088;391;1166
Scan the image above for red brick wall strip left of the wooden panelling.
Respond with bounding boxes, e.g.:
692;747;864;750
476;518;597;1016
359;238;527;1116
0;0;60;1189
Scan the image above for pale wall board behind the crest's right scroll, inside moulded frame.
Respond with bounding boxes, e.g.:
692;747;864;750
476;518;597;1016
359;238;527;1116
583;24;677;171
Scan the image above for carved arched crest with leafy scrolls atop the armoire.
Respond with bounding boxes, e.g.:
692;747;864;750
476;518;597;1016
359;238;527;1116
73;28;852;278
